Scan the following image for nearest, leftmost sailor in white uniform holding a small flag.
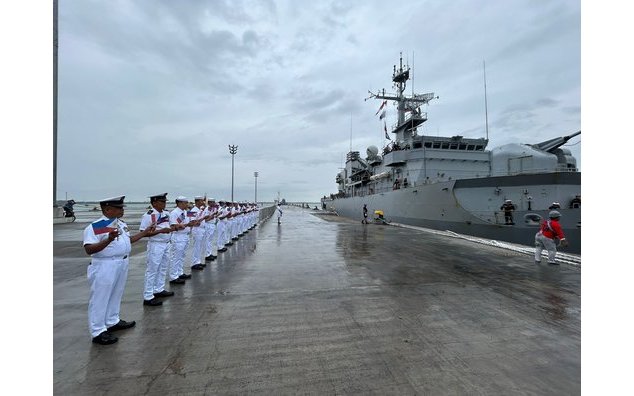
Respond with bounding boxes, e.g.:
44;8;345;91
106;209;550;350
83;196;154;345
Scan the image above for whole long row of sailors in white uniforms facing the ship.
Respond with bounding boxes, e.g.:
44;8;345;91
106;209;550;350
83;193;259;345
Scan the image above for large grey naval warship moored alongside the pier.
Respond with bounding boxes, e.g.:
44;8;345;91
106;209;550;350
321;55;581;254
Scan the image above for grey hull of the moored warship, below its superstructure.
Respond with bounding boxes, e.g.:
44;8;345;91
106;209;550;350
324;172;581;254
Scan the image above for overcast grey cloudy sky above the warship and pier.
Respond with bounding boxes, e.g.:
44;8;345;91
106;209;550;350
57;0;581;202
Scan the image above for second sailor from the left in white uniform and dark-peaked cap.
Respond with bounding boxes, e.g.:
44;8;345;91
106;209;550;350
139;193;174;306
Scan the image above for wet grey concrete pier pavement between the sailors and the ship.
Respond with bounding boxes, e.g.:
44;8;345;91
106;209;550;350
53;207;581;395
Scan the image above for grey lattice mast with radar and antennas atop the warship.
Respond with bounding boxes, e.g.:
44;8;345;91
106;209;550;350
367;52;438;144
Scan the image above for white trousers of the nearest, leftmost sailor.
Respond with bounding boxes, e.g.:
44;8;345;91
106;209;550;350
87;257;128;337
